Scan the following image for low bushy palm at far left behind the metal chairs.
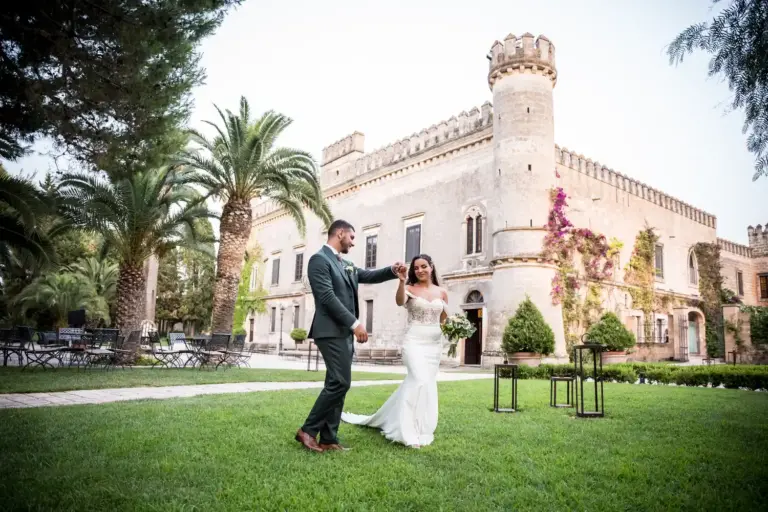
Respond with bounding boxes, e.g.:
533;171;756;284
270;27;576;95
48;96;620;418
13;272;110;329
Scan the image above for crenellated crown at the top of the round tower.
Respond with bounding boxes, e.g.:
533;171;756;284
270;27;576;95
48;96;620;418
488;32;557;89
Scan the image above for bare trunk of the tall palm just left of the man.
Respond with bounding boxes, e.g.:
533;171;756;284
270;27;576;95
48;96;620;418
211;199;251;333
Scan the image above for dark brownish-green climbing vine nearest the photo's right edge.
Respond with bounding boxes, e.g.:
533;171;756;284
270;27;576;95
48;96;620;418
693;242;725;357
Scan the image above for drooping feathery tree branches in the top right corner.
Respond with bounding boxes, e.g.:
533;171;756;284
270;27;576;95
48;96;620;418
667;0;768;180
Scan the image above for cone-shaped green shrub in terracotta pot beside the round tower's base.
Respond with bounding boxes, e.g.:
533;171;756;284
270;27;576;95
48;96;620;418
501;296;555;366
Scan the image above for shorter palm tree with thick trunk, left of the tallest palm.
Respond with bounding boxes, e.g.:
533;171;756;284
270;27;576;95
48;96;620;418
60;167;212;332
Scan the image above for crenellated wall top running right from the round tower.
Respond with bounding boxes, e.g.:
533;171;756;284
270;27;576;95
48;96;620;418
555;145;717;228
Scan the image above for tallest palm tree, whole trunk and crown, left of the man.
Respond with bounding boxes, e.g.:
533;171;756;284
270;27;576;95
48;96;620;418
180;97;332;332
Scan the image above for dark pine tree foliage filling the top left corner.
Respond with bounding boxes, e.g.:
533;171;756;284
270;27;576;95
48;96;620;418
0;0;242;172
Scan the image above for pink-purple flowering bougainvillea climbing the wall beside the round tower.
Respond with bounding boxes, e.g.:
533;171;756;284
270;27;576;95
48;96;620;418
542;187;622;353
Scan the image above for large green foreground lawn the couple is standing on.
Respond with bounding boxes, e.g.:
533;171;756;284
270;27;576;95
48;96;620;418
0;380;768;511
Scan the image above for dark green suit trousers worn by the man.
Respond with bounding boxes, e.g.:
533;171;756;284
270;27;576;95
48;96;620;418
301;335;354;444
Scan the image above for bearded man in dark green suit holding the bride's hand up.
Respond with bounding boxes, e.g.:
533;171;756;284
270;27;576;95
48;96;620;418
296;220;405;452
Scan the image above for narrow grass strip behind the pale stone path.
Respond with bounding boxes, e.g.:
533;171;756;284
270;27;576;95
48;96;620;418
0;367;403;393
